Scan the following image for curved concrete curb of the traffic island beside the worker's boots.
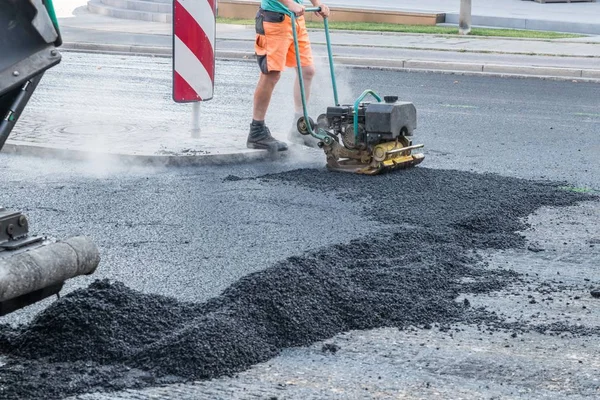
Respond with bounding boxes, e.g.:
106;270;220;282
2;139;287;167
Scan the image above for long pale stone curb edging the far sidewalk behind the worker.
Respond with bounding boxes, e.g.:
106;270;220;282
63;43;600;83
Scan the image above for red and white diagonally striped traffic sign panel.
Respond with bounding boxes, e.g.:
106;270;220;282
173;0;217;103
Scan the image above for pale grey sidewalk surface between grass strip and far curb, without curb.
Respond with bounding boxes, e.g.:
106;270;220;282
60;11;600;57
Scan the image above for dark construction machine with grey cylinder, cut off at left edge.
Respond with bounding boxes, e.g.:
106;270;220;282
0;0;100;316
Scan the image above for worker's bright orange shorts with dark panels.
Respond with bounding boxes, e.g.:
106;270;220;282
254;9;313;74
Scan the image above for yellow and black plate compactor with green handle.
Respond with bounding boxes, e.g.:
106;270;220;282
291;7;425;175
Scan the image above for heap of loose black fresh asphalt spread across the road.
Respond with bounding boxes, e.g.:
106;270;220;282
0;168;591;399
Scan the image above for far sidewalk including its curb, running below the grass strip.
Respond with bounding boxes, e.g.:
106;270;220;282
60;11;600;79
